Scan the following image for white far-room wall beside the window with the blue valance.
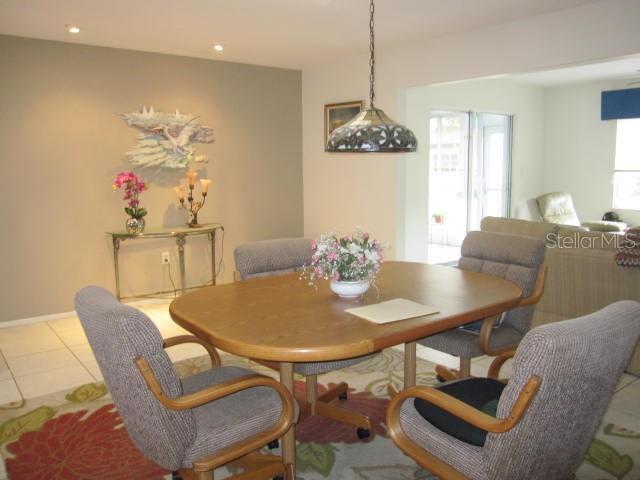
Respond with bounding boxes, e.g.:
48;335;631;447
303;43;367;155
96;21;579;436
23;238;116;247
543;81;640;225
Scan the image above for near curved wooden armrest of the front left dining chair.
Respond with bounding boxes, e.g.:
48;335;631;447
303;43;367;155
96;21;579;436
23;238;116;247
135;357;295;471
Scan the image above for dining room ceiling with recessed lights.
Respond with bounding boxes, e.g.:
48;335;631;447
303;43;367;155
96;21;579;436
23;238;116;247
0;0;594;69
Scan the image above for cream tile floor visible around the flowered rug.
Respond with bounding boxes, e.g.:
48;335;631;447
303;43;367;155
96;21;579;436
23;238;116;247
0;300;640;479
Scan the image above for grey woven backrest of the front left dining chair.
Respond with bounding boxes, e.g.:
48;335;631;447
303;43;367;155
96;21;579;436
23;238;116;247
75;287;196;470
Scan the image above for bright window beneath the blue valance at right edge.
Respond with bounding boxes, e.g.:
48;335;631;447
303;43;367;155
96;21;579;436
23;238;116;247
613;118;640;210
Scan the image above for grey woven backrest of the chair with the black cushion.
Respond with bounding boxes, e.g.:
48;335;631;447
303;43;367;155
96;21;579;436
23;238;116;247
483;300;640;480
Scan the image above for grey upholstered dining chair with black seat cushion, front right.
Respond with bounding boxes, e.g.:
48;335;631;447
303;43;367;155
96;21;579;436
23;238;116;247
387;301;640;480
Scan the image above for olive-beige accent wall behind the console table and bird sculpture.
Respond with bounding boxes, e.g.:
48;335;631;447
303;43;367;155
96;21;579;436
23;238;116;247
0;36;303;321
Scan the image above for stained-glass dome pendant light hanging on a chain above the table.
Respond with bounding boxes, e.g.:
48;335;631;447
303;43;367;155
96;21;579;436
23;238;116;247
325;0;418;153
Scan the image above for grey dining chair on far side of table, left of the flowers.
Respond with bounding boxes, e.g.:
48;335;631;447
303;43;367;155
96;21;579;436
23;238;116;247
234;238;373;439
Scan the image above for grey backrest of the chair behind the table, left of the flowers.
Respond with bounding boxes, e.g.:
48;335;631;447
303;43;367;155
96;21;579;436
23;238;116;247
233;238;313;280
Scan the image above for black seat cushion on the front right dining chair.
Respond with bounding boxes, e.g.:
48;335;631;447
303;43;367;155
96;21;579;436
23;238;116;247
414;378;506;447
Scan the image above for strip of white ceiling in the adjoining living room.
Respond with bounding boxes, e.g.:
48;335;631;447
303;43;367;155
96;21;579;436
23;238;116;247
510;55;640;87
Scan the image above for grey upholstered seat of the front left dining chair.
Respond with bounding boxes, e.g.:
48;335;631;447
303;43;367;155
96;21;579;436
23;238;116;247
182;367;297;468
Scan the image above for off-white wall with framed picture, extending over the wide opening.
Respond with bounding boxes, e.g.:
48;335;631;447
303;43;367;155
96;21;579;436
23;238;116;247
303;0;640;257
